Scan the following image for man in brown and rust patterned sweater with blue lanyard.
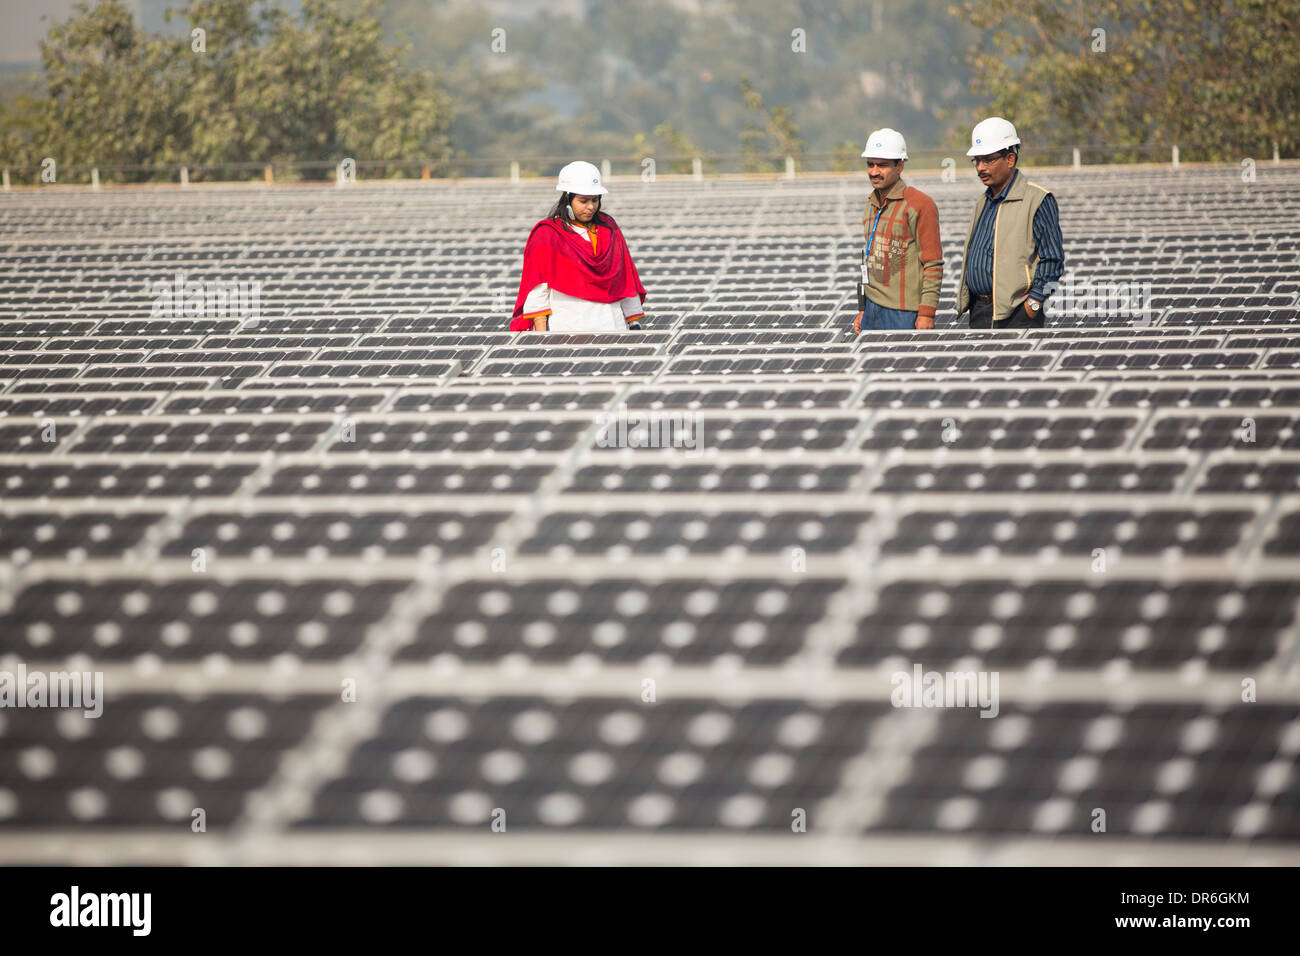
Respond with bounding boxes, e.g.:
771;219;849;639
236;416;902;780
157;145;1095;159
853;129;944;333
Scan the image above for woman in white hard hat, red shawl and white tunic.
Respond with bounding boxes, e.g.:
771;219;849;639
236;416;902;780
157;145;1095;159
510;163;646;332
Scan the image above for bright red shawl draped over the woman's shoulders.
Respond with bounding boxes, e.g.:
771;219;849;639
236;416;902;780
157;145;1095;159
514;213;646;317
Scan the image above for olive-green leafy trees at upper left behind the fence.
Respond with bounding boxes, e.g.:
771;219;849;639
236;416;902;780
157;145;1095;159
0;0;450;178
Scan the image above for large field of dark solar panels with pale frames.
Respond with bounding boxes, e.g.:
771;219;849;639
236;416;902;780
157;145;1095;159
0;165;1300;864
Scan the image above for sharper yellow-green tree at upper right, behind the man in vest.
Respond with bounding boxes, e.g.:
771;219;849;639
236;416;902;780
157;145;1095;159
954;0;1300;160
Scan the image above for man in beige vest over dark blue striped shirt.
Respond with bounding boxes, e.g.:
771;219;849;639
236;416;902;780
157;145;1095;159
957;116;1065;329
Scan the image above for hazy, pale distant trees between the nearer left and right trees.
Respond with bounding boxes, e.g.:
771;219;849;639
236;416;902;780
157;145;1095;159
384;0;975;172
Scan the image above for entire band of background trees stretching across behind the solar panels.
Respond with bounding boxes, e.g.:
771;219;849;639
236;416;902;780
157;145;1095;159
0;0;1300;176
